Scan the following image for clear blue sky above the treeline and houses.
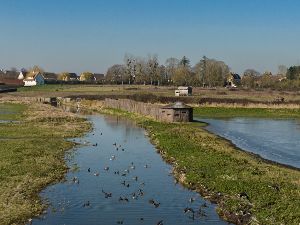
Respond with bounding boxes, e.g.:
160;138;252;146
0;0;300;73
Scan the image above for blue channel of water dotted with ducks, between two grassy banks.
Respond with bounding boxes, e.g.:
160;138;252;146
32;116;227;225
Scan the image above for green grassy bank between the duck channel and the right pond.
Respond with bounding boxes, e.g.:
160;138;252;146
84;102;300;225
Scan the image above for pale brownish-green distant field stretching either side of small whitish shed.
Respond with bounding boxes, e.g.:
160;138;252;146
14;84;300;102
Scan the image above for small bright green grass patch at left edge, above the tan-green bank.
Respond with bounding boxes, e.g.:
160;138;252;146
0;103;27;120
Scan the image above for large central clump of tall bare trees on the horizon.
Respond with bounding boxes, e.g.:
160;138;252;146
105;55;230;87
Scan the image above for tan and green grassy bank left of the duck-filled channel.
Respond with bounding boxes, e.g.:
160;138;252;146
0;101;90;224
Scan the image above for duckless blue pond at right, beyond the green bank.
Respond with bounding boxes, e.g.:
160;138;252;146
197;118;300;168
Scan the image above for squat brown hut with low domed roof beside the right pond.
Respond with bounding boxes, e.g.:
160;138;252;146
160;102;193;122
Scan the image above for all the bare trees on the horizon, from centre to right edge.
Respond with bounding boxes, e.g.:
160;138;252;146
105;55;300;90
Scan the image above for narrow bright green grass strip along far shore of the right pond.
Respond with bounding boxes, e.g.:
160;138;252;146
194;107;300;119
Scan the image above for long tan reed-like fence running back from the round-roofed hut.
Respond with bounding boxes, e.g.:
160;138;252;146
104;98;162;120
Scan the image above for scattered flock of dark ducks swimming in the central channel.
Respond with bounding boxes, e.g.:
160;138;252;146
71;129;207;225
